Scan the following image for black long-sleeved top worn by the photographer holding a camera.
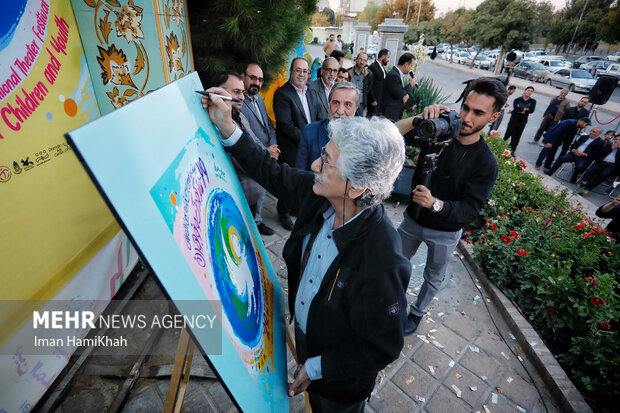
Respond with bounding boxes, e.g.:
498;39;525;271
407;138;498;231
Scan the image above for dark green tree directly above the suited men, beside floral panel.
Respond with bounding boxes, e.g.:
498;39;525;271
187;0;316;85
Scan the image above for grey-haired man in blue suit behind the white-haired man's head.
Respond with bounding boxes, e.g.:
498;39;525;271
295;82;359;171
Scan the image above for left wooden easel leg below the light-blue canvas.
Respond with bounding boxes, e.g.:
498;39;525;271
164;328;194;413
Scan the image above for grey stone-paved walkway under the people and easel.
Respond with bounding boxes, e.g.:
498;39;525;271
50;197;558;413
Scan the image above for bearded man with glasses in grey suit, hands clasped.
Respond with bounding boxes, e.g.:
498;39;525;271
241;63;280;235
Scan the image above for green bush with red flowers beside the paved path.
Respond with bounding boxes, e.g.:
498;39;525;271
469;135;620;411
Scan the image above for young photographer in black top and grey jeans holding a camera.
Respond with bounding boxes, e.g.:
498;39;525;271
397;78;508;334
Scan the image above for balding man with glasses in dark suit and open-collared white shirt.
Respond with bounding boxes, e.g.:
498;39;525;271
273;57;316;231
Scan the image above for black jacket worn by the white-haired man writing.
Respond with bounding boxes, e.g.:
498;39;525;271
228;134;411;402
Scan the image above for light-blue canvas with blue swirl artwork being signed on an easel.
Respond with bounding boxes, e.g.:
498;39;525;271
67;73;288;412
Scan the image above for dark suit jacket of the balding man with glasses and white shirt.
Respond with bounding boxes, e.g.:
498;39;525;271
273;81;316;165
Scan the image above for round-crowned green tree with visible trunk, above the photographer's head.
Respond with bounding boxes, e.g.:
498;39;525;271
468;0;537;74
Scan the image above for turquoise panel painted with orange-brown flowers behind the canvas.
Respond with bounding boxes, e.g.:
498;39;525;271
71;0;194;113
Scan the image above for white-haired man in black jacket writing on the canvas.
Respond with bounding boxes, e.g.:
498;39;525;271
203;88;411;412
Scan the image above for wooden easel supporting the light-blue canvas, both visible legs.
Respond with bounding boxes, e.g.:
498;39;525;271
164;327;312;413
